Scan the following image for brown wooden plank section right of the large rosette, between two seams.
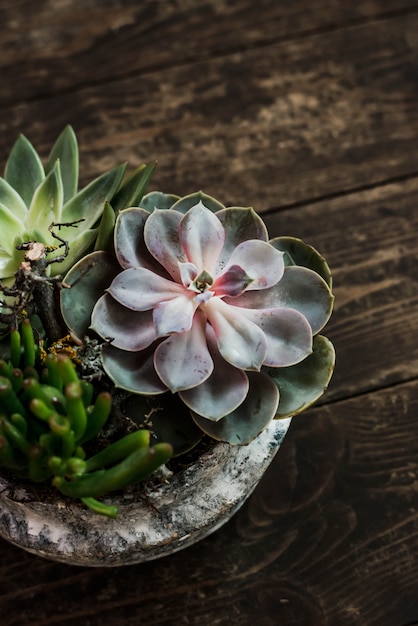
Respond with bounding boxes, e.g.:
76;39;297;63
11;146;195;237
265;179;418;401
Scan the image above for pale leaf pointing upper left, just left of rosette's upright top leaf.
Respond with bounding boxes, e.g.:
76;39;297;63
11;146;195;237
144;209;187;282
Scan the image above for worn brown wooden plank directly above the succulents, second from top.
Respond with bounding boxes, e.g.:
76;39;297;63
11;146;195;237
0;14;418;210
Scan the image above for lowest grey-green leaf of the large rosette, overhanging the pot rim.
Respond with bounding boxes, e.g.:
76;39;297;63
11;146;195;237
192;372;279;445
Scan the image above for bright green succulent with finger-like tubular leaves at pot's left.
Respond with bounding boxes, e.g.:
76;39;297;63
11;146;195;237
0;319;172;517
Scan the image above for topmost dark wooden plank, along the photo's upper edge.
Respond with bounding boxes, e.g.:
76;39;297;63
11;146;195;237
0;0;418;104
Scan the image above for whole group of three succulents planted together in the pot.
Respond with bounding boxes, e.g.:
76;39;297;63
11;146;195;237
0;127;335;516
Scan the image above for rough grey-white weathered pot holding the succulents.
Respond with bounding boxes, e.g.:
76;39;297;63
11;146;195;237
0;419;291;566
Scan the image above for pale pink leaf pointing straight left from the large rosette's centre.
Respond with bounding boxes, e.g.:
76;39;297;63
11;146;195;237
109;267;186;311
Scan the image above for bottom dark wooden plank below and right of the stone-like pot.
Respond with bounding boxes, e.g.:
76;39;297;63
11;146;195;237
0;382;418;626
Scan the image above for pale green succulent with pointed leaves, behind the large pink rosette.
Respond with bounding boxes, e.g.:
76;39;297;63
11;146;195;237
0;126;155;282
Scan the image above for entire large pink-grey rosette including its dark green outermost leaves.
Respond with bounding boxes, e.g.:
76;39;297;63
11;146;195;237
61;192;335;452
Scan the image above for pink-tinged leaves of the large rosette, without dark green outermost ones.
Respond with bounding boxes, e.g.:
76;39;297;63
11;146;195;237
81;201;333;443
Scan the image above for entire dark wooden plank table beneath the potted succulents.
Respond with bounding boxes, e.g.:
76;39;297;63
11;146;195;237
0;0;418;626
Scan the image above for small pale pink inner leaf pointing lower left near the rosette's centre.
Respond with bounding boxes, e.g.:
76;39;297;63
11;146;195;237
153;292;198;337
